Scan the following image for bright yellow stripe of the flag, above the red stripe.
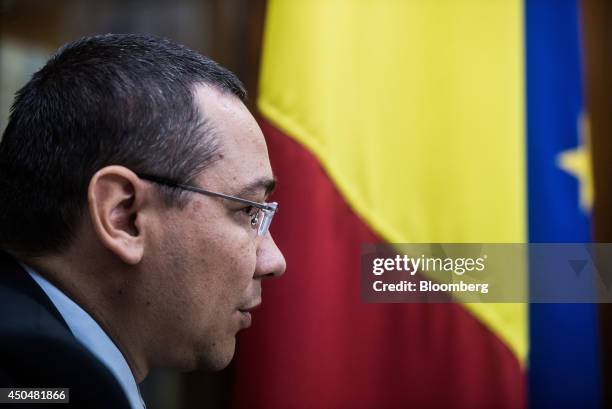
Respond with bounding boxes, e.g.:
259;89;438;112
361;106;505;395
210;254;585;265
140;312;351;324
258;0;527;362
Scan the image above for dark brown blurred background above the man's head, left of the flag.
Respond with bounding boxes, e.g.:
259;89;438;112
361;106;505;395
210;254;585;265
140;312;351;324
0;0;265;125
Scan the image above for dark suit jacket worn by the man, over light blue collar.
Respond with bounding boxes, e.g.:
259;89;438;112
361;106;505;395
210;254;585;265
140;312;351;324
0;251;130;409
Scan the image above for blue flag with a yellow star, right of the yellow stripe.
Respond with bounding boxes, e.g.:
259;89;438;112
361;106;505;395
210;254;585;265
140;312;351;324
525;0;602;409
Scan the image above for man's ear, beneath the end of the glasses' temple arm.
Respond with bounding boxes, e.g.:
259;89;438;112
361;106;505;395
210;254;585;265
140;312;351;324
87;166;146;264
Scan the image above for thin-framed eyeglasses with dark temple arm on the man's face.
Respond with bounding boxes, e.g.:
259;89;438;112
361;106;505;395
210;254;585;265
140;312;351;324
137;173;278;236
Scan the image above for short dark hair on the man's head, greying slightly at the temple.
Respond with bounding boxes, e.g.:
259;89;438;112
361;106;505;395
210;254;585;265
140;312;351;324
0;34;246;255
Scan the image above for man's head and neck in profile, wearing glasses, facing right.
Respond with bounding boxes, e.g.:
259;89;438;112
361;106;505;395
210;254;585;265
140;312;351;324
0;35;285;392
